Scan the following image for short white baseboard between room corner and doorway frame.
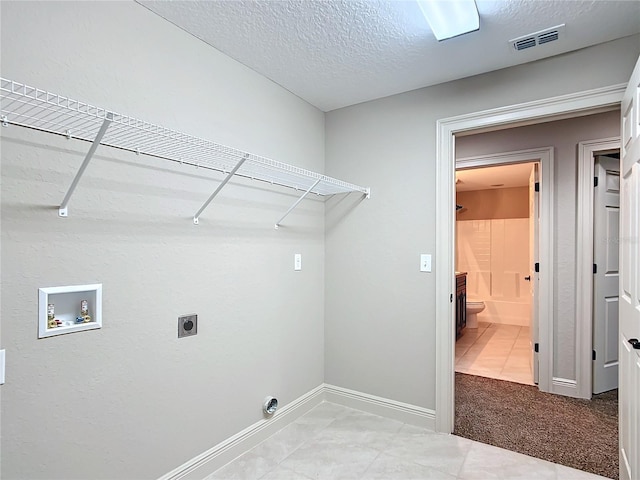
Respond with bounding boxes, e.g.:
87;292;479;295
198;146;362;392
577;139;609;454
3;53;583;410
324;384;436;430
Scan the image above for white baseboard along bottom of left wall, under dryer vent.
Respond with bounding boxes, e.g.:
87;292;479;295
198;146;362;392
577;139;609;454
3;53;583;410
159;385;324;480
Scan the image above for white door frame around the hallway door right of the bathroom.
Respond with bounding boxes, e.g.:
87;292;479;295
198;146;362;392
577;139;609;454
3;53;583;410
575;137;620;399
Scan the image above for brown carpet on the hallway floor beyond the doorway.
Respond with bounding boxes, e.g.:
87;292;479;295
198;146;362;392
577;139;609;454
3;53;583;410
454;373;618;479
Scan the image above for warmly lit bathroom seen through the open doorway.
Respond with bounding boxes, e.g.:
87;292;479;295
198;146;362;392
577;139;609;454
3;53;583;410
455;159;539;385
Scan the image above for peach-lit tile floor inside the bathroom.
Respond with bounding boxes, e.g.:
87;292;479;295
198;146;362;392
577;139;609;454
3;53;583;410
456;322;533;385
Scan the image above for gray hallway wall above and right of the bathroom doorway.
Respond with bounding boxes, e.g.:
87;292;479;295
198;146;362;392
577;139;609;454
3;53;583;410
456;110;620;380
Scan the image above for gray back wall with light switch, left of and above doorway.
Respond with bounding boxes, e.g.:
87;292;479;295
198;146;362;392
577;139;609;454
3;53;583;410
325;36;640;409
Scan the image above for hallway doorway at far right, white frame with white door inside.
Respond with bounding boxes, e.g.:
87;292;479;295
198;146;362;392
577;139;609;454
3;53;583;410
576;137;620;398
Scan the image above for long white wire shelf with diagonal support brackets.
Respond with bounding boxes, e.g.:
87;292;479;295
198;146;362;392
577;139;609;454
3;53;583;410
0;78;370;228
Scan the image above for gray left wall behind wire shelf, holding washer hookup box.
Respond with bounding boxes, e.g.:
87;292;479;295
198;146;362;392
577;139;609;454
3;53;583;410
1;2;324;479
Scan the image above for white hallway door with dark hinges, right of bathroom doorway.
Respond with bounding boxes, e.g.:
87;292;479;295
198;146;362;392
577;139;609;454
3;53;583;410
593;155;620;393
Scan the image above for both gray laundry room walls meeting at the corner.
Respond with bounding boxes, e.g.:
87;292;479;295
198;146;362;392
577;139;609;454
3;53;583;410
0;1;640;479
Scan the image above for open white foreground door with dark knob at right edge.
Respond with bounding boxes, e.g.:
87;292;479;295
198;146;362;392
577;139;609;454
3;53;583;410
618;54;640;480
